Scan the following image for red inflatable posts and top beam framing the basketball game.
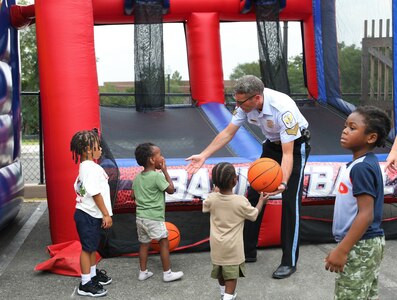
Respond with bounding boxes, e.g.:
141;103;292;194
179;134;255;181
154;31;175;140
35;0;318;244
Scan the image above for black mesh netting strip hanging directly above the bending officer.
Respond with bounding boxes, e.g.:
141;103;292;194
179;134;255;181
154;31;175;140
255;1;290;94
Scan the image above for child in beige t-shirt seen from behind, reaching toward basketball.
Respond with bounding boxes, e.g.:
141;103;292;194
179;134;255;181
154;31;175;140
203;162;267;300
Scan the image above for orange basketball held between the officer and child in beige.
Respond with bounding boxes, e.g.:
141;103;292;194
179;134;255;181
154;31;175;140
248;157;283;193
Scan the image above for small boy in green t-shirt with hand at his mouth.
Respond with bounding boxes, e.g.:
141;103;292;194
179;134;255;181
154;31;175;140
131;143;183;282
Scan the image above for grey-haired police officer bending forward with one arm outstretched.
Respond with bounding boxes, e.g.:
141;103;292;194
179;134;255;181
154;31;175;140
186;75;310;279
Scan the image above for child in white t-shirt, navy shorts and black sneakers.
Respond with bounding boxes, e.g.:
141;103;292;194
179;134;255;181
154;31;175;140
70;129;113;297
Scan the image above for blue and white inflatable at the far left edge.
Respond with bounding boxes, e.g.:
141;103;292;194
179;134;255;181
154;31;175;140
0;1;24;230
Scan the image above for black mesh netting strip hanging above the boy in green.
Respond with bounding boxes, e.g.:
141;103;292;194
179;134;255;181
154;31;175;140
134;1;165;112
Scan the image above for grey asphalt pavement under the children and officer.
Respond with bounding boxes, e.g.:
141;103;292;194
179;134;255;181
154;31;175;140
0;201;397;300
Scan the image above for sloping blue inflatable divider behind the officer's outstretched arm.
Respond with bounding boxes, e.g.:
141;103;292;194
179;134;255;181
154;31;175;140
201;103;262;161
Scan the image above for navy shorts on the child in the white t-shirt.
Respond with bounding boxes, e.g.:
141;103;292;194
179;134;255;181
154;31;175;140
74;209;102;252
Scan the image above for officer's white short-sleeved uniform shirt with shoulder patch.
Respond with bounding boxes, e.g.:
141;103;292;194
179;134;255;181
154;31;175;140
231;88;309;143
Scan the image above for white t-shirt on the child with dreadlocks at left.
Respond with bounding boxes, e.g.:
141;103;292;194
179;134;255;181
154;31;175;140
74;160;113;219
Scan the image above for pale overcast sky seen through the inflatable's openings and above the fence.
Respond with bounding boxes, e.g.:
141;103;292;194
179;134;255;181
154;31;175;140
95;0;392;85
